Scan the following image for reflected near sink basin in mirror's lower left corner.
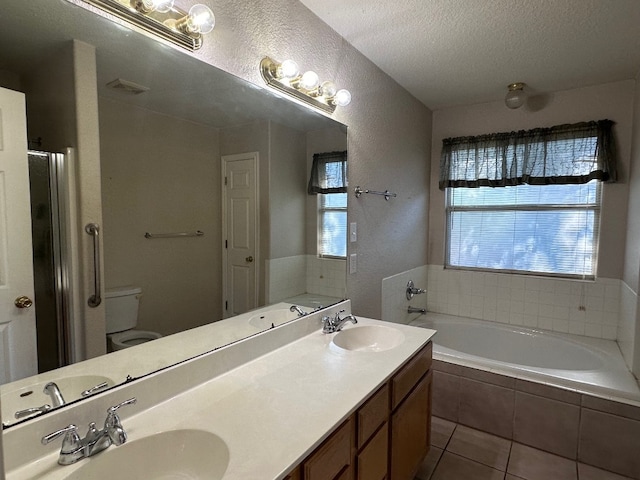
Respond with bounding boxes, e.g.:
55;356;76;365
0;375;114;424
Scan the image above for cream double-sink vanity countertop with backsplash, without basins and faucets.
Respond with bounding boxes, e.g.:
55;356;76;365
3;310;435;480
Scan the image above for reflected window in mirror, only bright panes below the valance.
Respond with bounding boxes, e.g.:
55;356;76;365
318;193;347;258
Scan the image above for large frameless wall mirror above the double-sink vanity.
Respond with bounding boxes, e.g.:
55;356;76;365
0;0;347;424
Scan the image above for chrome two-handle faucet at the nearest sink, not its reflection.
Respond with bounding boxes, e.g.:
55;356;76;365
42;398;136;465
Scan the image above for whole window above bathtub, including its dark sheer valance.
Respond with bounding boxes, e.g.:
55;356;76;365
440;120;616;278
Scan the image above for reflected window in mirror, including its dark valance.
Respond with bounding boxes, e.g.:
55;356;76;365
307;151;347;258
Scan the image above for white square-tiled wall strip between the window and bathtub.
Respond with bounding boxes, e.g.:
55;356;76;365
427;265;623;340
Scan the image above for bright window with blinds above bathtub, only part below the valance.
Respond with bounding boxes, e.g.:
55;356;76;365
446;180;601;278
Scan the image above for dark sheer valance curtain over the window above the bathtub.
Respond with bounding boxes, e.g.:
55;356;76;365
439;120;617;190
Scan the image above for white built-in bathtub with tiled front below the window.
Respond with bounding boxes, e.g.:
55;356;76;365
410;312;640;405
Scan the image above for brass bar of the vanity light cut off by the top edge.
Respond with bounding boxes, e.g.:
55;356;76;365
84;0;202;52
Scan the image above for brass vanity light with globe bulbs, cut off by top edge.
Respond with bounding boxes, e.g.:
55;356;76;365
84;0;215;51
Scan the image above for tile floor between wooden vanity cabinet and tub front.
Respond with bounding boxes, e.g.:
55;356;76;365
415;417;631;480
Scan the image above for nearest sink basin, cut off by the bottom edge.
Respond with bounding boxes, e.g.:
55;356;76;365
64;430;229;480
